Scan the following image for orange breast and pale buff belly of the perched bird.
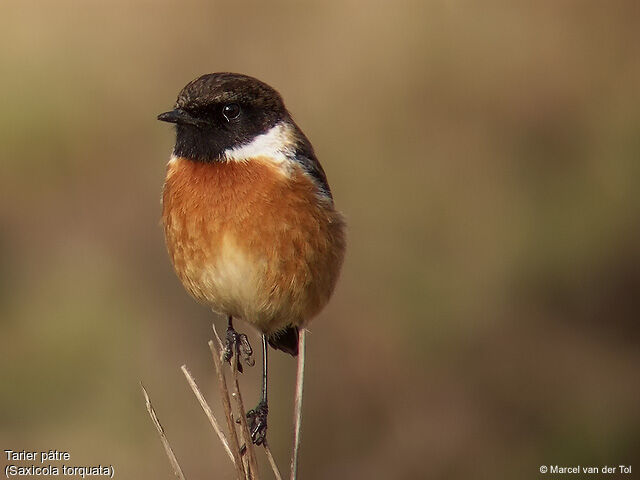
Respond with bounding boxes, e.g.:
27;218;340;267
162;158;345;333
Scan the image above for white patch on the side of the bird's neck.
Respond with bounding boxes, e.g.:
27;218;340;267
222;122;296;169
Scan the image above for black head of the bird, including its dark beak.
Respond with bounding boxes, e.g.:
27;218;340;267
158;73;291;162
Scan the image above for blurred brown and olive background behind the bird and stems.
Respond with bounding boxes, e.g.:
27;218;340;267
0;0;640;479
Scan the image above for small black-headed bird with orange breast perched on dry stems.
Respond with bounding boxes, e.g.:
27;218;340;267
157;72;346;445
